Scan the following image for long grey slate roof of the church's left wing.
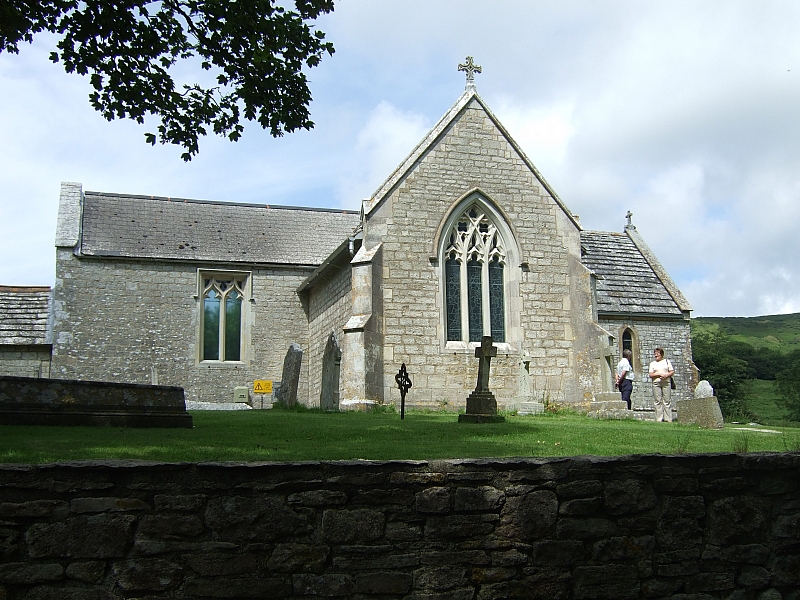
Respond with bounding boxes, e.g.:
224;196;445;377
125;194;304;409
81;192;360;266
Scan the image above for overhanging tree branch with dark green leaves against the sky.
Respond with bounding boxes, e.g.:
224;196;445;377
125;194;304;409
0;0;334;161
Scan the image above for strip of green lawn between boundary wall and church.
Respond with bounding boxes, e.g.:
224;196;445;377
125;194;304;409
0;410;800;463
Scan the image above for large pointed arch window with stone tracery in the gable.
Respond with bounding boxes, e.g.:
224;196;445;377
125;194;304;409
444;204;507;342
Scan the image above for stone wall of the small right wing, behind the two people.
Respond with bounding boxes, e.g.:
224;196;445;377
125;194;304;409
600;317;697;408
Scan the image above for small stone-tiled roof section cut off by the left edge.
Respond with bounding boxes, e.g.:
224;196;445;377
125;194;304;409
0;285;50;346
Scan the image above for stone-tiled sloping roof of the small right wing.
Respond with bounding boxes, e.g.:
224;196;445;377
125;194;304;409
581;231;691;317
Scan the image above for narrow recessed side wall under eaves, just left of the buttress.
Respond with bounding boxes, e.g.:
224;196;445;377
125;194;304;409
303;248;351;406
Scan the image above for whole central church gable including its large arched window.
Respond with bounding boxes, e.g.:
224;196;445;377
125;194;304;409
356;85;589;405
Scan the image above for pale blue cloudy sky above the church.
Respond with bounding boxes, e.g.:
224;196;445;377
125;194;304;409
0;0;800;316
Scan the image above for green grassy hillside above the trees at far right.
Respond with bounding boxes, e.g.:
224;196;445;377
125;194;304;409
692;313;800;354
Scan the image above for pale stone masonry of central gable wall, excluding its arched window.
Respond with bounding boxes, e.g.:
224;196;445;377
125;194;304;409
365;103;580;406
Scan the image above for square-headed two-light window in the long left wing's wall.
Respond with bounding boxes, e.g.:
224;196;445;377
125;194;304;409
200;275;246;362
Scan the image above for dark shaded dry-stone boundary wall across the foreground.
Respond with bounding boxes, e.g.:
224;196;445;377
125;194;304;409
0;453;800;600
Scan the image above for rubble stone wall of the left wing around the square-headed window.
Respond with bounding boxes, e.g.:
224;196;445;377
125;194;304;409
51;249;308;402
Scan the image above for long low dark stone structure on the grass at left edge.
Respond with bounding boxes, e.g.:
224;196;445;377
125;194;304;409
0;376;192;428
